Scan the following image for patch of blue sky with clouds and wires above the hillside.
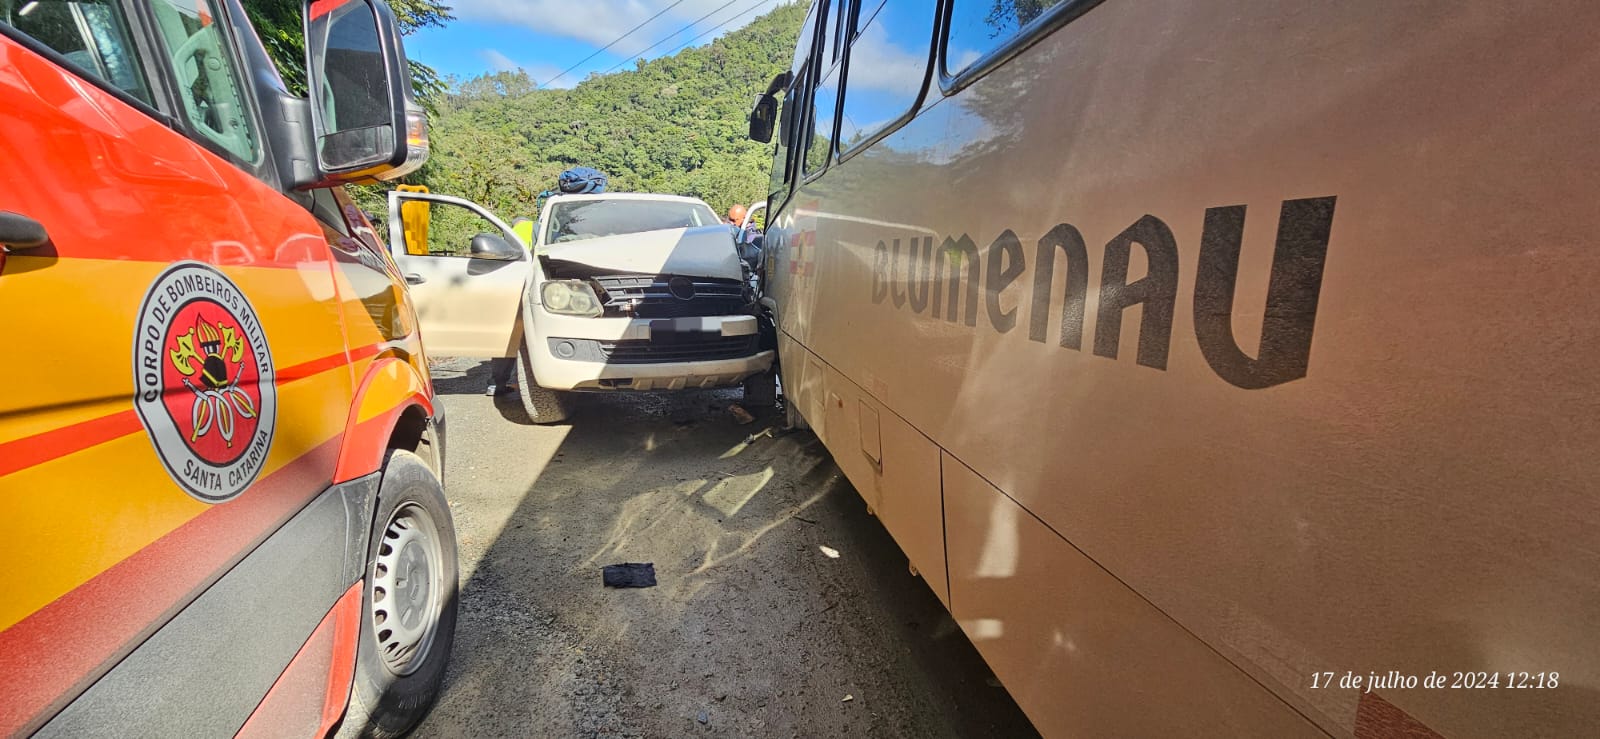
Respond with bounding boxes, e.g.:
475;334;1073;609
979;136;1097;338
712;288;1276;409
405;0;794;88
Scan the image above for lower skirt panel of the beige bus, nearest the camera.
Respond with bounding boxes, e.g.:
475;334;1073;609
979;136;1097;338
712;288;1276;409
942;454;1323;737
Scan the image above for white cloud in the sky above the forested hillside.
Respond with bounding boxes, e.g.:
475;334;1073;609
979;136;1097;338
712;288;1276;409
450;0;776;64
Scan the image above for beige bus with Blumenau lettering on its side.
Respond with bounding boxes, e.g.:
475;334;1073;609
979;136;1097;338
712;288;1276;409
750;0;1600;737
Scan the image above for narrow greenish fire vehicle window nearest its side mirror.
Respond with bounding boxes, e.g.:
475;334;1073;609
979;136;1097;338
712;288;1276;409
150;0;258;165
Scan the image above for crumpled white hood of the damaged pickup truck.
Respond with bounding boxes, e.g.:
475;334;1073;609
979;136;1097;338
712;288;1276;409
539;226;744;280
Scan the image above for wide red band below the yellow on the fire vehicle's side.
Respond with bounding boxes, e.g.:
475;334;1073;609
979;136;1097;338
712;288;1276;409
0;437;344;736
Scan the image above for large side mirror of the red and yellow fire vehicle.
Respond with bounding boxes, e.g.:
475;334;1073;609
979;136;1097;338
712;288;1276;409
306;0;429;184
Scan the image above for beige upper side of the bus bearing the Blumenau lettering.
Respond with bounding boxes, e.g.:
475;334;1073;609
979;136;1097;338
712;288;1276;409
778;2;1600;736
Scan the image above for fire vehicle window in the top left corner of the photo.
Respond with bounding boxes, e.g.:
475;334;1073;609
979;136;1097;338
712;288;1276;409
0;0;152;104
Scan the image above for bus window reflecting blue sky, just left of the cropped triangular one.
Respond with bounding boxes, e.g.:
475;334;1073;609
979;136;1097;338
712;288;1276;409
838;0;933;150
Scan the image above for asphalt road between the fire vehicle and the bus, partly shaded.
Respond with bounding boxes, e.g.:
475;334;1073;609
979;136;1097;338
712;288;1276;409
416;360;1035;737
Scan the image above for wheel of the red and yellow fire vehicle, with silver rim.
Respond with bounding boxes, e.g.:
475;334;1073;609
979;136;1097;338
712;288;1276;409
338;449;459;737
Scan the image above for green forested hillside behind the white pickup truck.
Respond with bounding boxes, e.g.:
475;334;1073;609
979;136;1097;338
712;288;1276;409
406;2;806;219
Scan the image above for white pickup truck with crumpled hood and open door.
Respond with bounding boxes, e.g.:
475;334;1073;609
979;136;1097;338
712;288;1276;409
389;192;776;424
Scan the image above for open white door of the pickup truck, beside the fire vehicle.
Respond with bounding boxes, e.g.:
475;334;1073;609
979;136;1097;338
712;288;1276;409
389;190;533;357
